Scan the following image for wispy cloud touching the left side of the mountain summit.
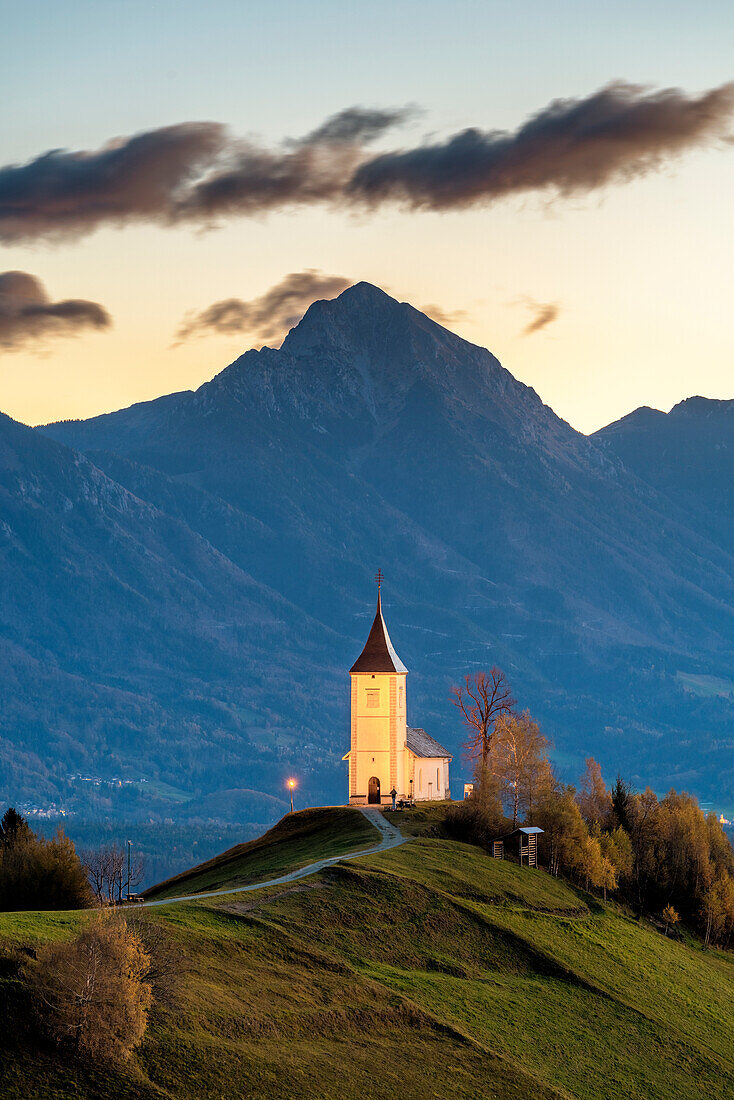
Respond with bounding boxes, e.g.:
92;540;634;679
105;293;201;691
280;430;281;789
176;270;352;345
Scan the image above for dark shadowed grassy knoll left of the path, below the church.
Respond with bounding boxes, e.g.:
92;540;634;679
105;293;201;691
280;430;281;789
145;806;380;900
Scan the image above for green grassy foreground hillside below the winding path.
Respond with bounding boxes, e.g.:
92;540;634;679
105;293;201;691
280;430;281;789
0;812;734;1100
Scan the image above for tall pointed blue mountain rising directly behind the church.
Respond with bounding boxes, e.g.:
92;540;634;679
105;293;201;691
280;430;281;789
31;284;734;802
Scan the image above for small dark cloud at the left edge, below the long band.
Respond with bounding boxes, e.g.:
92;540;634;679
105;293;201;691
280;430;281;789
0;272;111;351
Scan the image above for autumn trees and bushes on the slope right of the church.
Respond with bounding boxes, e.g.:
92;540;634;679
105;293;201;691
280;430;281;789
447;668;734;946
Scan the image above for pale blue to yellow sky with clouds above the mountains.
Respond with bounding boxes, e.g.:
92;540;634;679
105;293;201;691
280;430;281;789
0;0;734;432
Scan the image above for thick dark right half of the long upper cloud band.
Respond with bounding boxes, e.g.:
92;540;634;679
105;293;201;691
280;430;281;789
347;83;734;210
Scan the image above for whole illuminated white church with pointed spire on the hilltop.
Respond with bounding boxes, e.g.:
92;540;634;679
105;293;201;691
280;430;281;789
342;573;452;806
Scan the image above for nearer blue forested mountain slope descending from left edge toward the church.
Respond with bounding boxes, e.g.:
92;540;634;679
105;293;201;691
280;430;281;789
0;407;351;823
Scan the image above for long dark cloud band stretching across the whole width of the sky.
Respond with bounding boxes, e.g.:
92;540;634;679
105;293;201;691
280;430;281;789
0;84;734;242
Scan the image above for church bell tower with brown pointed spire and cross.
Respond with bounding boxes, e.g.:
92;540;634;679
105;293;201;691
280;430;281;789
344;571;408;806
